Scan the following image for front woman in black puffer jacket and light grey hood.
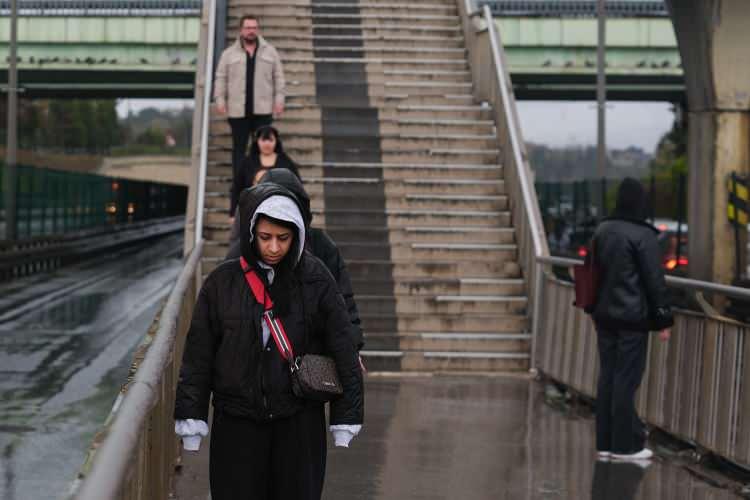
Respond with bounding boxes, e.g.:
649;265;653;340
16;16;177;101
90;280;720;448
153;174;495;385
174;184;364;500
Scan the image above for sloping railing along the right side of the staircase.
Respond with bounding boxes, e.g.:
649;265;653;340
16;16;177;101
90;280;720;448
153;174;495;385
458;0;549;362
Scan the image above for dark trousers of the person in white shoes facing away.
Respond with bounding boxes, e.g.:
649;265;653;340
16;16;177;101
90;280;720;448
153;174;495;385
596;329;648;454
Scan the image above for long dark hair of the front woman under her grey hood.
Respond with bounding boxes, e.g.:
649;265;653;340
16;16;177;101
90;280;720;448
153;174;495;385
252;214;300;315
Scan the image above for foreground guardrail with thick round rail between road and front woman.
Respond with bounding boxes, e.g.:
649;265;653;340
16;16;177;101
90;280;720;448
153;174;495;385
76;241;203;500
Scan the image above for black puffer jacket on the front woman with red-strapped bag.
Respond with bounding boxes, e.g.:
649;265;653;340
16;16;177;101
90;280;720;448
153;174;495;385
174;184;364;424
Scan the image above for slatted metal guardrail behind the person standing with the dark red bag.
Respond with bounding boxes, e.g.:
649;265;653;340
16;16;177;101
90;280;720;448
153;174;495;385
534;257;750;467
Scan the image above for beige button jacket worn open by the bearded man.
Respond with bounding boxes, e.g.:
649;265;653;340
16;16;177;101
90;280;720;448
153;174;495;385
214;37;286;118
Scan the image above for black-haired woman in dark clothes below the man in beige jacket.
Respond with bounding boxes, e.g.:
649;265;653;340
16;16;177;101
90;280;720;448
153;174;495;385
229;125;299;223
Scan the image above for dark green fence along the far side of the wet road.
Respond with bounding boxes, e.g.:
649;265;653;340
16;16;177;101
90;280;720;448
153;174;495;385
0;165;187;239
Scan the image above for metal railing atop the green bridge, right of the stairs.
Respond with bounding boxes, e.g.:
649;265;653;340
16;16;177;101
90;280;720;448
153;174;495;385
479;0;669;17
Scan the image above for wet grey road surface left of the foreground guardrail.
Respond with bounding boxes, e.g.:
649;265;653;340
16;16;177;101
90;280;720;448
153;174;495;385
0;235;182;500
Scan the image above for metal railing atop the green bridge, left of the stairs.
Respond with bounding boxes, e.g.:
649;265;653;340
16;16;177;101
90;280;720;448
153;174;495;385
0;0;203;17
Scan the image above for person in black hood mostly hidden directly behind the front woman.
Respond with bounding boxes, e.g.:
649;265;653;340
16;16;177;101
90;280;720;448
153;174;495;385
226;168;365;351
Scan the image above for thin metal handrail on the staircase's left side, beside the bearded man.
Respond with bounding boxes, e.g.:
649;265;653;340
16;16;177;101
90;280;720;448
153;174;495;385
195;0;216;244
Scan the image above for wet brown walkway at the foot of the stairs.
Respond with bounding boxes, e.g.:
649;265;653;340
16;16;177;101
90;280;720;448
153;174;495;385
177;376;740;500
